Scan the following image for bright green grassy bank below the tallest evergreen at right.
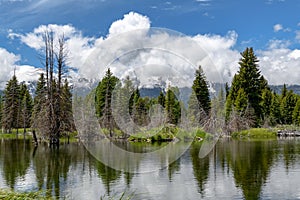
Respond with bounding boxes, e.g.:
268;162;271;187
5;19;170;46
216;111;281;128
231;128;277;139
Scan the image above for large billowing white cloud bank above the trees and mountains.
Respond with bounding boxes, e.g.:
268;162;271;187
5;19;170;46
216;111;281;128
0;12;300;86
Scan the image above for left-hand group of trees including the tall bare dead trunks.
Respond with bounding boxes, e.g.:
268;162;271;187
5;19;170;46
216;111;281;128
0;31;75;146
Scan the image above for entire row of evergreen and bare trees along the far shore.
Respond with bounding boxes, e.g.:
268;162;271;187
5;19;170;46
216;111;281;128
0;45;300;144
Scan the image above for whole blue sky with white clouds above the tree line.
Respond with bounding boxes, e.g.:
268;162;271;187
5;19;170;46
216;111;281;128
0;0;300;88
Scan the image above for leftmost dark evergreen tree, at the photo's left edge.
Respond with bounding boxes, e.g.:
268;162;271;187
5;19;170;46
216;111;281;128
2;75;20;133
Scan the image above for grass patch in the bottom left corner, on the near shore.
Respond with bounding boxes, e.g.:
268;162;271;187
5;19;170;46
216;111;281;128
0;189;51;200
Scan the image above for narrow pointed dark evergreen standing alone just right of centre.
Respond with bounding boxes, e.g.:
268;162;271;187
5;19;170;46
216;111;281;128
192;66;211;116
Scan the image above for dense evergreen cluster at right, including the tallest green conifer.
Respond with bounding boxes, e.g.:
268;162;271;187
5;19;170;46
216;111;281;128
226;48;300;131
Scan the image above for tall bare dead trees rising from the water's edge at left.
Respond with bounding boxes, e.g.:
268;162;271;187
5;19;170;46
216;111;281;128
34;30;67;147
